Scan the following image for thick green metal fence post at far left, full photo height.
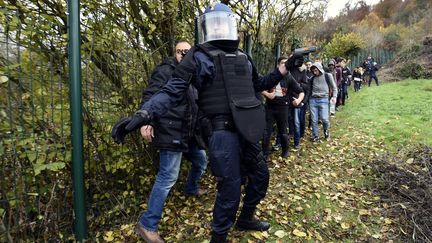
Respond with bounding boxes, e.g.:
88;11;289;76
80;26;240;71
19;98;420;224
68;0;87;242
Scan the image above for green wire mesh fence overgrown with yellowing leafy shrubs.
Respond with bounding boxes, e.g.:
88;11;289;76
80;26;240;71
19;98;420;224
0;6;274;242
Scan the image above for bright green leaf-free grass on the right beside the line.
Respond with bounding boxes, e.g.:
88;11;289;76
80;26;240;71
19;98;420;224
337;79;432;149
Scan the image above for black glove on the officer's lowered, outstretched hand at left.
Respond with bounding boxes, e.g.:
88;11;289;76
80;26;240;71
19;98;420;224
111;110;151;144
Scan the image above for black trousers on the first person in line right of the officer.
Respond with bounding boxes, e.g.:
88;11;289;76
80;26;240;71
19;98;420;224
262;104;288;156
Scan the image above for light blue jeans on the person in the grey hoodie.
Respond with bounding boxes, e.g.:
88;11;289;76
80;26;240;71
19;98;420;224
309;97;330;138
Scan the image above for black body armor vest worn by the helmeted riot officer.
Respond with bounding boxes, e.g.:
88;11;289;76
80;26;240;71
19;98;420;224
198;43;265;143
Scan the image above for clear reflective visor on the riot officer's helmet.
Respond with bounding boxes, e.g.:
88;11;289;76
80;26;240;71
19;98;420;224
198;11;238;44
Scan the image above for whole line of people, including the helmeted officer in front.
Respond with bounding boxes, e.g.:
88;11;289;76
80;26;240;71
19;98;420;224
111;3;380;243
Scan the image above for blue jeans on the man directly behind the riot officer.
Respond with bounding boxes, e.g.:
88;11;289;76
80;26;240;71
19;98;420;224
139;143;207;231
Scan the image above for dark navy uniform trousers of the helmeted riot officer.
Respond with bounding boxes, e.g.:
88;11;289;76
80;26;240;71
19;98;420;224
208;130;269;235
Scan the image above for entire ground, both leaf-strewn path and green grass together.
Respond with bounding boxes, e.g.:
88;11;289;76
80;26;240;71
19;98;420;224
93;80;432;242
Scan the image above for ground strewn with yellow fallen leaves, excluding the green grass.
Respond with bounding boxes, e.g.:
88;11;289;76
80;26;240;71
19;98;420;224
95;117;393;242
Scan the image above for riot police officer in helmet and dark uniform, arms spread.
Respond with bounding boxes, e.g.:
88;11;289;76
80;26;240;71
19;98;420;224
112;4;287;242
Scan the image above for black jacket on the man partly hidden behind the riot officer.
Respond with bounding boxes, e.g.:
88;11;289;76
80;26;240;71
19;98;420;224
142;57;204;152
